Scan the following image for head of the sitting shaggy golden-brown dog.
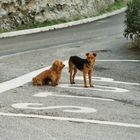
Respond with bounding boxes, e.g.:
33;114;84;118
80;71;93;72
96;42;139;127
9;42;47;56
52;60;65;72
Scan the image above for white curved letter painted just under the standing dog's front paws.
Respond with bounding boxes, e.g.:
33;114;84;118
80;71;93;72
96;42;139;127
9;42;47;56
58;84;129;92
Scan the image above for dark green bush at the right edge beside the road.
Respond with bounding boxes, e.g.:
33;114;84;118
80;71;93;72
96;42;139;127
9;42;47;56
124;0;140;47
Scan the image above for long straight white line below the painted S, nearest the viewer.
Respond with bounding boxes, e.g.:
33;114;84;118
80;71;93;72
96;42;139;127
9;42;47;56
0;112;140;129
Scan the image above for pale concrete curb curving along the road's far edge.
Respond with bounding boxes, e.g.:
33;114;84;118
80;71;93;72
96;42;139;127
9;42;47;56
0;7;126;38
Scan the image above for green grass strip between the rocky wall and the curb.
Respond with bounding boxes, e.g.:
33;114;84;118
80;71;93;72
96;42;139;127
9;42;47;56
0;0;129;33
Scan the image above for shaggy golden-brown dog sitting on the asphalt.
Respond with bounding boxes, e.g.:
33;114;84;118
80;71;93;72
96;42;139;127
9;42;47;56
32;60;65;86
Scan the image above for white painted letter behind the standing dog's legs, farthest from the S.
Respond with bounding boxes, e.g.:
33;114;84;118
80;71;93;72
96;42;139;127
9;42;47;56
75;76;140;86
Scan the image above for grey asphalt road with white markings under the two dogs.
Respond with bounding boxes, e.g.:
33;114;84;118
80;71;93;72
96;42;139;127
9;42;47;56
0;13;140;140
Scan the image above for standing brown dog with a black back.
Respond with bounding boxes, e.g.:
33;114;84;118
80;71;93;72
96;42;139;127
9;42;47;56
69;52;96;87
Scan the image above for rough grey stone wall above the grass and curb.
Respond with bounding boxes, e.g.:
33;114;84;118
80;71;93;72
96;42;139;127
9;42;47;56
0;0;114;29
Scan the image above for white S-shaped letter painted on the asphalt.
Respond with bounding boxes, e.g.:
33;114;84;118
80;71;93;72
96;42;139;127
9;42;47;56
12;103;97;113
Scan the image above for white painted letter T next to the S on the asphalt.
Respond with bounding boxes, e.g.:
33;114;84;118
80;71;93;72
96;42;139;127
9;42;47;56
33;92;114;101
